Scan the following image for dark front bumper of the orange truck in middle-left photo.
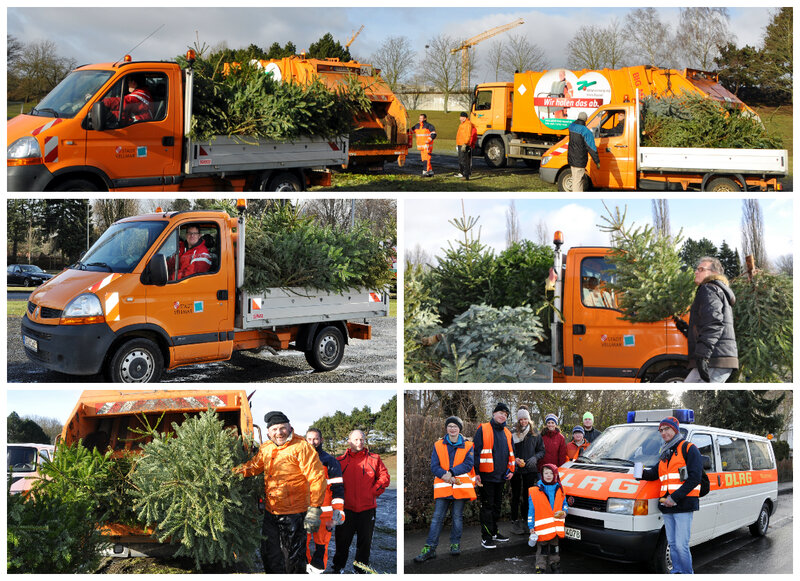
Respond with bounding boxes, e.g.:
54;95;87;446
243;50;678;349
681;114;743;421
20;314;114;375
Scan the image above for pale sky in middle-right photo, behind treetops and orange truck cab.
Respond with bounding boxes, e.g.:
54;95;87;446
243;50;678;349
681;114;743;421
402;198;794;260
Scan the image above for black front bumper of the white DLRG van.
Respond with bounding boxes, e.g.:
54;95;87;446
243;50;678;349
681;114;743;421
564;515;661;563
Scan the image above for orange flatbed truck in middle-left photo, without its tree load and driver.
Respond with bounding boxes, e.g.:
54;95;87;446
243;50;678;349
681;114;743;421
22;203;389;383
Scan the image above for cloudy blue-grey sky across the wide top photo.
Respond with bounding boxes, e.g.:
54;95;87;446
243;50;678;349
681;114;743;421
7;2;773;82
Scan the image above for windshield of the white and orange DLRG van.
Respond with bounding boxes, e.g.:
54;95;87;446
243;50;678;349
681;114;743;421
578;424;686;467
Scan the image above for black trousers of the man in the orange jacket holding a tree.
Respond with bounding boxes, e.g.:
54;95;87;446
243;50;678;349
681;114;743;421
261;512;307;573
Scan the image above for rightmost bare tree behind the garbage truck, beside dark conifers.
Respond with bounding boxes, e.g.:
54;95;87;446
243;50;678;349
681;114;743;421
675;8;736;70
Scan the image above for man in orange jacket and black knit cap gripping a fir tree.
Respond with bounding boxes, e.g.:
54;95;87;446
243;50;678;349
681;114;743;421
233;411;326;573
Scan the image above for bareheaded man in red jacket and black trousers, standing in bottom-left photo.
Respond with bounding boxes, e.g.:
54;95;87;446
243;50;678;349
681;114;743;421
333;430;389;573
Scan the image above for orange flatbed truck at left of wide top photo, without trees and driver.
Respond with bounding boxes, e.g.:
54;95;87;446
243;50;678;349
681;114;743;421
7;54;349;191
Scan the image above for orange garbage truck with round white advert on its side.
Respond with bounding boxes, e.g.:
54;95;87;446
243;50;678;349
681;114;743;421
470;66;755;168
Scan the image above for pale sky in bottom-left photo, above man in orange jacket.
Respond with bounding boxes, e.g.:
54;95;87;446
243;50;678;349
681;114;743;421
6;386;397;434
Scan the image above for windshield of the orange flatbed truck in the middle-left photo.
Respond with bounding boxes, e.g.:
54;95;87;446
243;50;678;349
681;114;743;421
76;221;167;273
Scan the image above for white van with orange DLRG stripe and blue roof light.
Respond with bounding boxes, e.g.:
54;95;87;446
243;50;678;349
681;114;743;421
559;409;778;573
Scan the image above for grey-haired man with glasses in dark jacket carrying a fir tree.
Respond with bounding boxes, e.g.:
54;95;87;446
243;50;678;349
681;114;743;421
685;256;739;383
